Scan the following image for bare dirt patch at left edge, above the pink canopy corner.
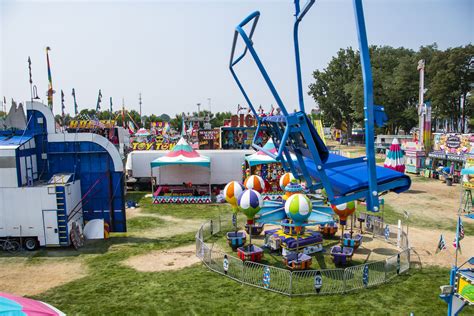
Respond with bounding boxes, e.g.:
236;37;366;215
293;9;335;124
0;258;86;296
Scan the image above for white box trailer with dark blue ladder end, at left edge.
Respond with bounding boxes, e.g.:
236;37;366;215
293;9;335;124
0;174;83;250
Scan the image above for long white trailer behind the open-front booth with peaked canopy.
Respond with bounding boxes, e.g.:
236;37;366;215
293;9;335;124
125;149;255;190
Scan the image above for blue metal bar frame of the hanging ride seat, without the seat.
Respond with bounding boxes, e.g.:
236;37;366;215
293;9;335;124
229;0;386;211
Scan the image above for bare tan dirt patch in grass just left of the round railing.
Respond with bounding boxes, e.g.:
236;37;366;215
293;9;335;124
124;245;199;272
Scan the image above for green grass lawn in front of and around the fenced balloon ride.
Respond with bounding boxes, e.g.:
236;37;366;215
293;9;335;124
17;193;456;315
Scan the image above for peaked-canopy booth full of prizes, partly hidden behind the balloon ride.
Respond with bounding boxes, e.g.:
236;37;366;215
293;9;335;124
242;138;292;201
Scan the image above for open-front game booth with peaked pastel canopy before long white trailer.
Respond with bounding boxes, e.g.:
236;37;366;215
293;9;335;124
151;138;211;204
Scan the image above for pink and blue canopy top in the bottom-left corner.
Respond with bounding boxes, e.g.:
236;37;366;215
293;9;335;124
0;292;65;316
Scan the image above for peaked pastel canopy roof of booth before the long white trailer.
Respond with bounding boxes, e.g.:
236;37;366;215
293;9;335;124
151;137;211;168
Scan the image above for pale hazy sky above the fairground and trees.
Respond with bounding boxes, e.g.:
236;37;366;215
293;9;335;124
0;0;474;115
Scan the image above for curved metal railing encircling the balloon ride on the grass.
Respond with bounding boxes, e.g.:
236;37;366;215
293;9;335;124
196;218;411;296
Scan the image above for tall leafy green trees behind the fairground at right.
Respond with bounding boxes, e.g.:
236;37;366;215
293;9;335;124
308;44;474;141
